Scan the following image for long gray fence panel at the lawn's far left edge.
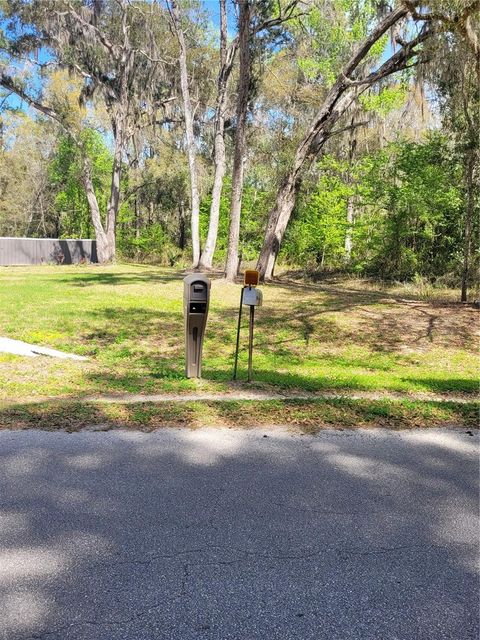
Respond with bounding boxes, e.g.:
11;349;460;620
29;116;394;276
0;238;98;266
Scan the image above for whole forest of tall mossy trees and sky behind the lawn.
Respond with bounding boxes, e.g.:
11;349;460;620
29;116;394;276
0;0;480;301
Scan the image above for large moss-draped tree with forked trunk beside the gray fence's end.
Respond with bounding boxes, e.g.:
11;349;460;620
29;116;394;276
0;0;172;262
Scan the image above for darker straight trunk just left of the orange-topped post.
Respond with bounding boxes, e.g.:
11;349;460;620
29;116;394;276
225;0;251;281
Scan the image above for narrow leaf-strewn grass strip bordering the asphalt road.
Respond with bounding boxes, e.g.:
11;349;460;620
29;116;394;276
0;398;478;433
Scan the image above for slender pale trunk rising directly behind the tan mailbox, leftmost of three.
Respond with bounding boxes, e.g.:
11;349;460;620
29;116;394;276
170;0;200;268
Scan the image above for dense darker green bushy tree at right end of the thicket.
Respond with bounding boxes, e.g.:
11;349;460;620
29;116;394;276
353;132;462;280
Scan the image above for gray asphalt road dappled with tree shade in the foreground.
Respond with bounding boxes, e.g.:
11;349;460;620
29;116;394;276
0;430;479;640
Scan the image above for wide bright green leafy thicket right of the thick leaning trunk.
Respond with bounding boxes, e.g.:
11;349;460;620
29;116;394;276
281;131;463;284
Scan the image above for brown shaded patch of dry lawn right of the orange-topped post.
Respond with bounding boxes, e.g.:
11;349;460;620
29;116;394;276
258;289;478;353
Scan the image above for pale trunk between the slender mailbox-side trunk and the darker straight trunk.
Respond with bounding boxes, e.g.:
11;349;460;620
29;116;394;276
200;0;237;269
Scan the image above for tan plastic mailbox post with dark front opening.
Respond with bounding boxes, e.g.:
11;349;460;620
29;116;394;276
183;273;210;378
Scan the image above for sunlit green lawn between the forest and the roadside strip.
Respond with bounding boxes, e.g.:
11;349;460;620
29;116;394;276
0;265;478;430
